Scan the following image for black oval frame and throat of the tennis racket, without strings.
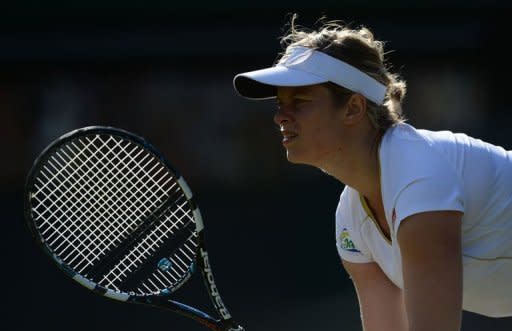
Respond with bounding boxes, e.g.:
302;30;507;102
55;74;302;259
24;126;244;331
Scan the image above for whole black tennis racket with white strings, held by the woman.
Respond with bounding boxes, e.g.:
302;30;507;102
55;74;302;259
25;126;244;331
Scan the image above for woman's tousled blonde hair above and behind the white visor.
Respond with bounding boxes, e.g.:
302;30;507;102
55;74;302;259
281;14;406;130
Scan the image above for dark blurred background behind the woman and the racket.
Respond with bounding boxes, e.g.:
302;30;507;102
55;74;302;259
4;0;512;331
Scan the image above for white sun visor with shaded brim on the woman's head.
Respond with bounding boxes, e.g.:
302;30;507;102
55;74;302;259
233;46;386;105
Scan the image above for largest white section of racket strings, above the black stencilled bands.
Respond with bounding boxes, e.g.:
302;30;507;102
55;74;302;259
33;135;180;278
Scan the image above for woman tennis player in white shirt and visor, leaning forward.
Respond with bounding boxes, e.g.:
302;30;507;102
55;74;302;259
234;18;512;331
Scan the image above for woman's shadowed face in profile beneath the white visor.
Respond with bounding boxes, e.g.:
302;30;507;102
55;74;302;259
274;85;344;167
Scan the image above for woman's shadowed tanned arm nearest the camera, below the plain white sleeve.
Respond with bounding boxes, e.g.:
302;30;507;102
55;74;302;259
397;211;462;331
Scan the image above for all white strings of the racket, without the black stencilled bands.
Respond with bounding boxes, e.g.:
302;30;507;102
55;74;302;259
31;135;197;294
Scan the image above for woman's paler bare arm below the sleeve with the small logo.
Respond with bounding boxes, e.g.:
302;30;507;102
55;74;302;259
343;260;407;331
